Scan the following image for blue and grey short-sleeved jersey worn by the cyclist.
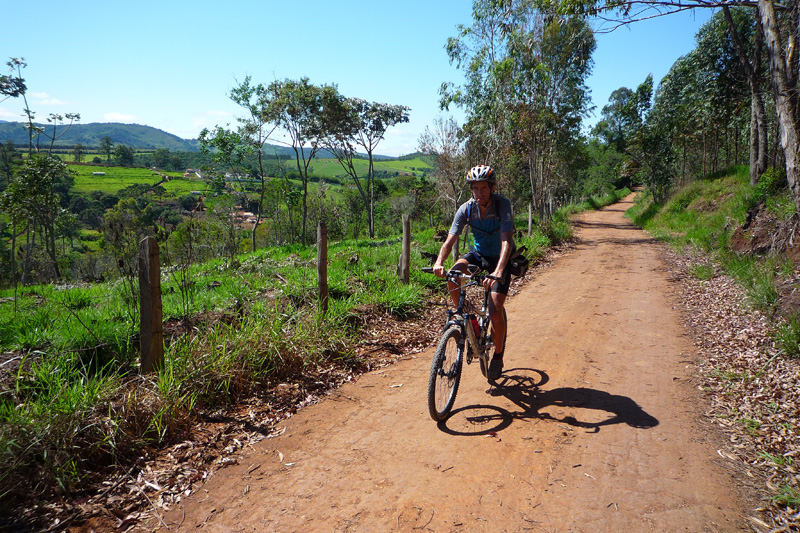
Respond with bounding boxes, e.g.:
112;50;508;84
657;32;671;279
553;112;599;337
450;194;514;257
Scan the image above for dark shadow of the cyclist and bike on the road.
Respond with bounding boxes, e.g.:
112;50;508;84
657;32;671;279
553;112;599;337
439;368;659;435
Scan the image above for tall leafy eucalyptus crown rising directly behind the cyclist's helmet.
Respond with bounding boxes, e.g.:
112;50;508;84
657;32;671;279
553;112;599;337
440;0;595;214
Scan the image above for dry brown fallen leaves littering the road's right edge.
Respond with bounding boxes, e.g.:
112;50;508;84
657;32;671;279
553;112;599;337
666;246;800;531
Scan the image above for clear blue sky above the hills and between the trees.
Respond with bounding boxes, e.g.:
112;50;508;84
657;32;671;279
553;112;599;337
0;0;711;156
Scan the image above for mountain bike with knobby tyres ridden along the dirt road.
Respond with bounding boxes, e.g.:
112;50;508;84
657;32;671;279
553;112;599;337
422;266;505;422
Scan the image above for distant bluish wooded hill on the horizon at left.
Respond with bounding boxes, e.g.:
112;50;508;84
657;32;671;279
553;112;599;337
0;120;400;160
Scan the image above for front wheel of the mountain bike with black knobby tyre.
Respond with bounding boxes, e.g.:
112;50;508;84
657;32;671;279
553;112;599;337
428;326;463;422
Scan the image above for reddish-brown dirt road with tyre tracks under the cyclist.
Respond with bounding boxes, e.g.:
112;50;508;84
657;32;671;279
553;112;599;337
155;194;750;532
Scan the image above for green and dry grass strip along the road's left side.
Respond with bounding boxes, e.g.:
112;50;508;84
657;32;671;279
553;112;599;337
0;187;627;511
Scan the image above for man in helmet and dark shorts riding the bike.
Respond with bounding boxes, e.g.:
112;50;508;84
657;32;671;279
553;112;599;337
433;165;514;381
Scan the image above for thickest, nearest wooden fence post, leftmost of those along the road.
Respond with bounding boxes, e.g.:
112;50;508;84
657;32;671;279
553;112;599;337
139;237;164;374
